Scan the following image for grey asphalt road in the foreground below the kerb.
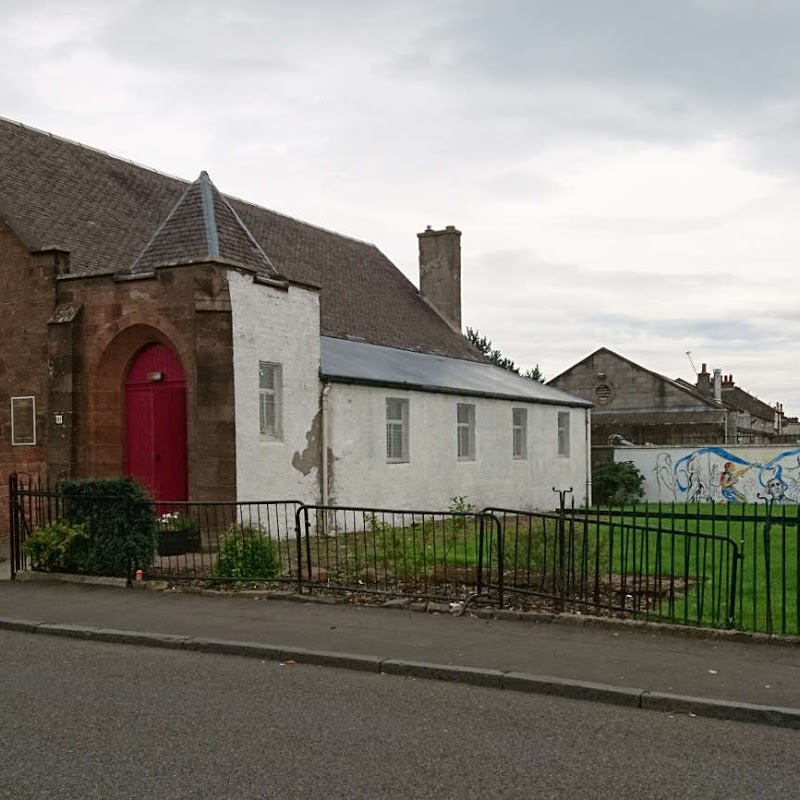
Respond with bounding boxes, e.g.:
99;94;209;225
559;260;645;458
0;632;800;800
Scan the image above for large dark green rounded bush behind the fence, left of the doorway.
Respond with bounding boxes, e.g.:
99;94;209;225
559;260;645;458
58;478;157;576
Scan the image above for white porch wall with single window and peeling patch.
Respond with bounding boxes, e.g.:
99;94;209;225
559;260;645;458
228;271;321;503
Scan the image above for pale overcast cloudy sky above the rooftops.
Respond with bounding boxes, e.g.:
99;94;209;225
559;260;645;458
0;0;800;415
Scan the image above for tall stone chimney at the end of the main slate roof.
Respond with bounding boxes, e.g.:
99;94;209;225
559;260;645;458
417;225;461;333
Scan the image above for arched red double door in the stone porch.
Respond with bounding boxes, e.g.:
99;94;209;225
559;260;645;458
125;344;188;500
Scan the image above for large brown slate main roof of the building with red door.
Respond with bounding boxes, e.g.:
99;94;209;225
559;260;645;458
0;119;484;361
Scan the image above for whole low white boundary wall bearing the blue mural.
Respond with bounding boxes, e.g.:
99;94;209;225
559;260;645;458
614;445;800;503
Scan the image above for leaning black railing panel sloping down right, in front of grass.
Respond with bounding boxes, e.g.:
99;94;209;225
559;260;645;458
489;507;740;627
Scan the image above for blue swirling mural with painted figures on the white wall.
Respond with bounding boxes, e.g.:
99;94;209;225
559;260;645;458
654;447;800;503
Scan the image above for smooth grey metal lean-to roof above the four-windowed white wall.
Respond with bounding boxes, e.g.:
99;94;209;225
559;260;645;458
320;336;591;407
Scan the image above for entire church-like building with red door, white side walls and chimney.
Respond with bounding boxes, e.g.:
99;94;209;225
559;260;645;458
0;120;590;536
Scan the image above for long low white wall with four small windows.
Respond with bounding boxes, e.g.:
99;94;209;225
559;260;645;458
327;383;588;510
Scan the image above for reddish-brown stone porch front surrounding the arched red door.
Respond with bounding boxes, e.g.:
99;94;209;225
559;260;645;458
56;265;236;500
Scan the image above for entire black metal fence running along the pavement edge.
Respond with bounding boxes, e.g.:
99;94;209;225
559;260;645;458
10;476;800;634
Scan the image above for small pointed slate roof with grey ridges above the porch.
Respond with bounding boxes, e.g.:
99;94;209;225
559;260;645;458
130;171;280;279
